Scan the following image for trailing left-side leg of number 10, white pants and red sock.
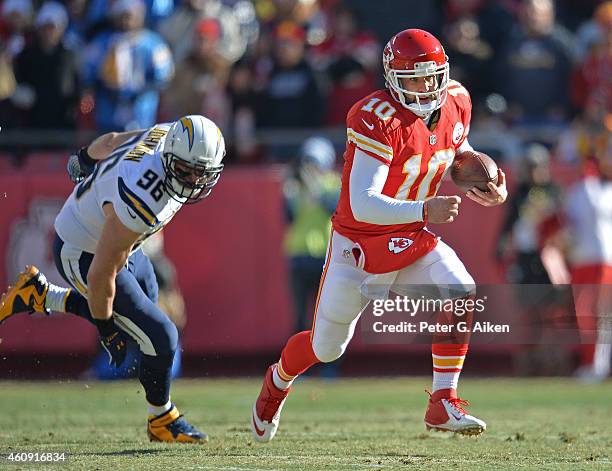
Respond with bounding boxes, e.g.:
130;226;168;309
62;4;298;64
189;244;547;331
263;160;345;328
251;232;367;442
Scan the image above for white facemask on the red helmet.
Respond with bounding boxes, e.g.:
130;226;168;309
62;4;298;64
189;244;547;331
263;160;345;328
385;59;449;118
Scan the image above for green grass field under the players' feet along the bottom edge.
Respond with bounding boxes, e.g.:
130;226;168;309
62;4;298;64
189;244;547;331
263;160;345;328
0;378;612;471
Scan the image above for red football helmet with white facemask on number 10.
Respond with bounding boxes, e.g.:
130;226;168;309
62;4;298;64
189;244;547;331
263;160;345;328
383;29;449;117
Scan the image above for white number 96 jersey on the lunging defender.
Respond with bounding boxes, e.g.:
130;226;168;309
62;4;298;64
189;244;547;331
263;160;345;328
55;124;182;253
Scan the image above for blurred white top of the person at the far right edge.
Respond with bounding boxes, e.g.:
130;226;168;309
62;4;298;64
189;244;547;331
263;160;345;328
565;177;612;265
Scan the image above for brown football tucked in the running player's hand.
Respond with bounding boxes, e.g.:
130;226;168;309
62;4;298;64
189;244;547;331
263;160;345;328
451;151;498;193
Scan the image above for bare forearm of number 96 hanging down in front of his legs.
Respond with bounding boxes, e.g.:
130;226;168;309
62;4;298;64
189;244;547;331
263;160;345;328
87;204;140;321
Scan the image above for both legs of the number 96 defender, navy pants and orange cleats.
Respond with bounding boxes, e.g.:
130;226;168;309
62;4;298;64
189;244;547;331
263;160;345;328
0;236;198;443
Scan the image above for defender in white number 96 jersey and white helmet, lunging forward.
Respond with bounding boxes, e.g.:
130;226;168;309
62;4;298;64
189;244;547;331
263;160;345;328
0;115;225;443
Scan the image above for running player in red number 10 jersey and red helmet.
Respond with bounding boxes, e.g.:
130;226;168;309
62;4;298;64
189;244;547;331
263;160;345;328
251;29;507;442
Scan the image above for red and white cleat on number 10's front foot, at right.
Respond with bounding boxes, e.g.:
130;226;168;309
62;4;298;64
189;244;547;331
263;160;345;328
425;389;487;436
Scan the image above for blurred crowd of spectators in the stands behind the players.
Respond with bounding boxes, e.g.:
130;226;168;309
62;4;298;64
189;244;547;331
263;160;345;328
0;0;612;164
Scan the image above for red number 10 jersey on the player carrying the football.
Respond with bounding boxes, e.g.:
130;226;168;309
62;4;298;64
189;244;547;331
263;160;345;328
332;80;472;240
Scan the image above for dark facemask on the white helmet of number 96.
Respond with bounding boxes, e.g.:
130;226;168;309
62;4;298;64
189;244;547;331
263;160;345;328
162;152;223;204
